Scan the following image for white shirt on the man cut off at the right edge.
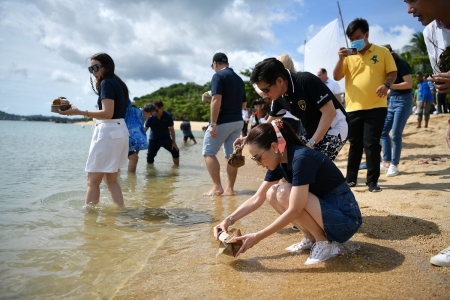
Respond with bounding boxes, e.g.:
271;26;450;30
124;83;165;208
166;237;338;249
423;20;450;74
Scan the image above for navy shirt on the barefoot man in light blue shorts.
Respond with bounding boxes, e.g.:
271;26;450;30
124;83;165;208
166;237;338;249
211;67;247;124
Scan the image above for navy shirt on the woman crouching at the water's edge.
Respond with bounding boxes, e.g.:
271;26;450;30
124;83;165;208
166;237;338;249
264;145;345;197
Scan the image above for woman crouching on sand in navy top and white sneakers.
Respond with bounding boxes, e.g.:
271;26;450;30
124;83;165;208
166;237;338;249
214;120;362;265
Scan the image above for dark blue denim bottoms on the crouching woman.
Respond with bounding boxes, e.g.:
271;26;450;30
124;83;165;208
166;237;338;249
318;182;362;243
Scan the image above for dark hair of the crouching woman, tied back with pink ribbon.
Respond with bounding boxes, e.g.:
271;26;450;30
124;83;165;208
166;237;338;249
246;122;305;150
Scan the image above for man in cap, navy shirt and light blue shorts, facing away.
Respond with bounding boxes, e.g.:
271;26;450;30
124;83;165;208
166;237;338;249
202;53;247;196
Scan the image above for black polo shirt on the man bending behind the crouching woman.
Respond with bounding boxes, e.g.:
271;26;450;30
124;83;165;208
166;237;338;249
270;70;347;139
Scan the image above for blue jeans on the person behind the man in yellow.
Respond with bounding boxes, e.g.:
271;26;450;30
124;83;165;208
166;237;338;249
381;93;412;165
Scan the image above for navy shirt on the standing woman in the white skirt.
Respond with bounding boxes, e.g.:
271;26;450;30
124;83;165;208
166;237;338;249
97;78;128;119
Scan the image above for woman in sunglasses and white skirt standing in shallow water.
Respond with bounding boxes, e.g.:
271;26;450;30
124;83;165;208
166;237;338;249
59;53;128;207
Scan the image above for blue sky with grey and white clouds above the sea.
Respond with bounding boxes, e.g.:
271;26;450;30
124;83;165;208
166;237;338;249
0;0;423;115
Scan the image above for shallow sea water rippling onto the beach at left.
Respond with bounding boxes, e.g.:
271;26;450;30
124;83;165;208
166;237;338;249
0;121;220;299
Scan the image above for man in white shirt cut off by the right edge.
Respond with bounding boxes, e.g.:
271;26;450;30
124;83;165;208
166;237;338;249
405;0;450;267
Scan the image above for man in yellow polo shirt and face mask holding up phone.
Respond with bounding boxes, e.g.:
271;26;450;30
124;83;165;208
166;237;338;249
333;18;397;192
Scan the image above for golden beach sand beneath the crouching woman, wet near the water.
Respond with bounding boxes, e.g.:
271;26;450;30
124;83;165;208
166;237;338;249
113;115;450;299
